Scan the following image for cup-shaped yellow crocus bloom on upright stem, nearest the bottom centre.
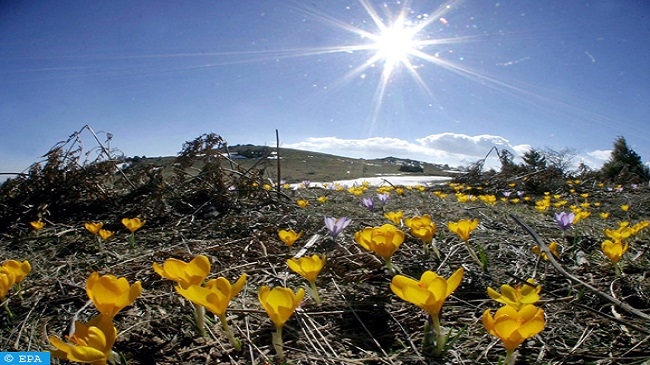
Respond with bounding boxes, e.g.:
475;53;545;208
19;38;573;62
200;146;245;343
258;285;305;328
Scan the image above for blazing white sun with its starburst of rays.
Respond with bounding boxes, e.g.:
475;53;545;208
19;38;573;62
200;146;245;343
290;0;471;130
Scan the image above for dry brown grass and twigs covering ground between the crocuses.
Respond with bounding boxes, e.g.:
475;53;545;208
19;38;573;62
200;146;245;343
0;130;650;364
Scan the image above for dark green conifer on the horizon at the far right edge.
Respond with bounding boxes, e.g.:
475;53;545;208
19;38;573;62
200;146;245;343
600;136;650;183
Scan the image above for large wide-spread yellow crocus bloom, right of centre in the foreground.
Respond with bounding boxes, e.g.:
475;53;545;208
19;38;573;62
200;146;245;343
390;267;465;317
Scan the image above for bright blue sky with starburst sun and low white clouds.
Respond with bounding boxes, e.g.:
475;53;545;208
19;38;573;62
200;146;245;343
0;0;650;172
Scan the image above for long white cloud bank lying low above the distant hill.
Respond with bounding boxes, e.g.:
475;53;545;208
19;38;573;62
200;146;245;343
283;132;610;168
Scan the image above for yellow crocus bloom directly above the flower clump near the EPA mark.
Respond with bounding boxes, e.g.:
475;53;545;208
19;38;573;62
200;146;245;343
86;272;142;318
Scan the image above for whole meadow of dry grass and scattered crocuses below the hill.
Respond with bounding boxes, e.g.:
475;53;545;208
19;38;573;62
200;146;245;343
0;132;650;364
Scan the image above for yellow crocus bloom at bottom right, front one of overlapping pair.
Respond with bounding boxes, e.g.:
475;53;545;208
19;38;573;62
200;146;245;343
483;304;546;352
